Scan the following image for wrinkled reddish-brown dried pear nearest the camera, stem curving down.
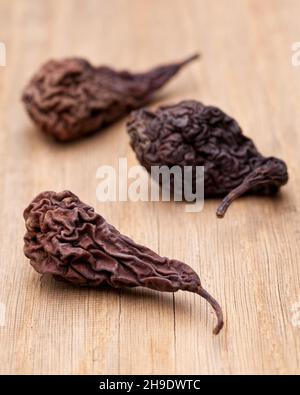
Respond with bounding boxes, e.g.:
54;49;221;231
24;191;223;334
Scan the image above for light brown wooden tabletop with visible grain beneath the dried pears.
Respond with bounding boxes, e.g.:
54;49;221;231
0;0;300;374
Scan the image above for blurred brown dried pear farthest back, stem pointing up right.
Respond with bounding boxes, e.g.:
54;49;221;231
22;55;198;141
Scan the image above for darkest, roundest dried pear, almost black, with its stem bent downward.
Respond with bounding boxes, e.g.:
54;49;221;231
127;100;288;217
